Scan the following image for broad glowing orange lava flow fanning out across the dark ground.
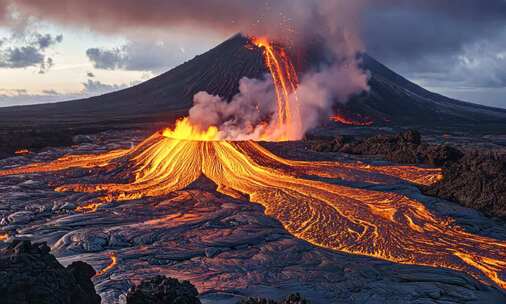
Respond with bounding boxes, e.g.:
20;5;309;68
0;131;506;289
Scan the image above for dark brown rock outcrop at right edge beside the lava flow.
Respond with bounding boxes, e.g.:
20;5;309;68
424;153;506;218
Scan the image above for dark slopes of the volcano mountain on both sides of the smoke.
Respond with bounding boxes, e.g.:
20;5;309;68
0;35;506;130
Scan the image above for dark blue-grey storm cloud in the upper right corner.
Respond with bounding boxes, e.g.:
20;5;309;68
363;0;506;60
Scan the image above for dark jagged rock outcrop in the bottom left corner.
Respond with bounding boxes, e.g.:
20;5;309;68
0;241;101;304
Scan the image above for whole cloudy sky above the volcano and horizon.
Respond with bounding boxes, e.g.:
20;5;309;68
0;0;506;108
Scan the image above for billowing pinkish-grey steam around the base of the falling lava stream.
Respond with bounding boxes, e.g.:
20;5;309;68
189;58;368;140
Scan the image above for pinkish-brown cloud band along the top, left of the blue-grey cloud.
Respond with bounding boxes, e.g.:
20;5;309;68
2;0;367;51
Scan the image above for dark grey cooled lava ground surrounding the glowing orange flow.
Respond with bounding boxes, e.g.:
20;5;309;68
0;132;506;304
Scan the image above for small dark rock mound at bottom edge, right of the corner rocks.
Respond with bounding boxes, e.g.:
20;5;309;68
127;276;200;304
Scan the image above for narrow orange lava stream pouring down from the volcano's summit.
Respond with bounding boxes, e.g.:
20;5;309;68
251;37;301;141
